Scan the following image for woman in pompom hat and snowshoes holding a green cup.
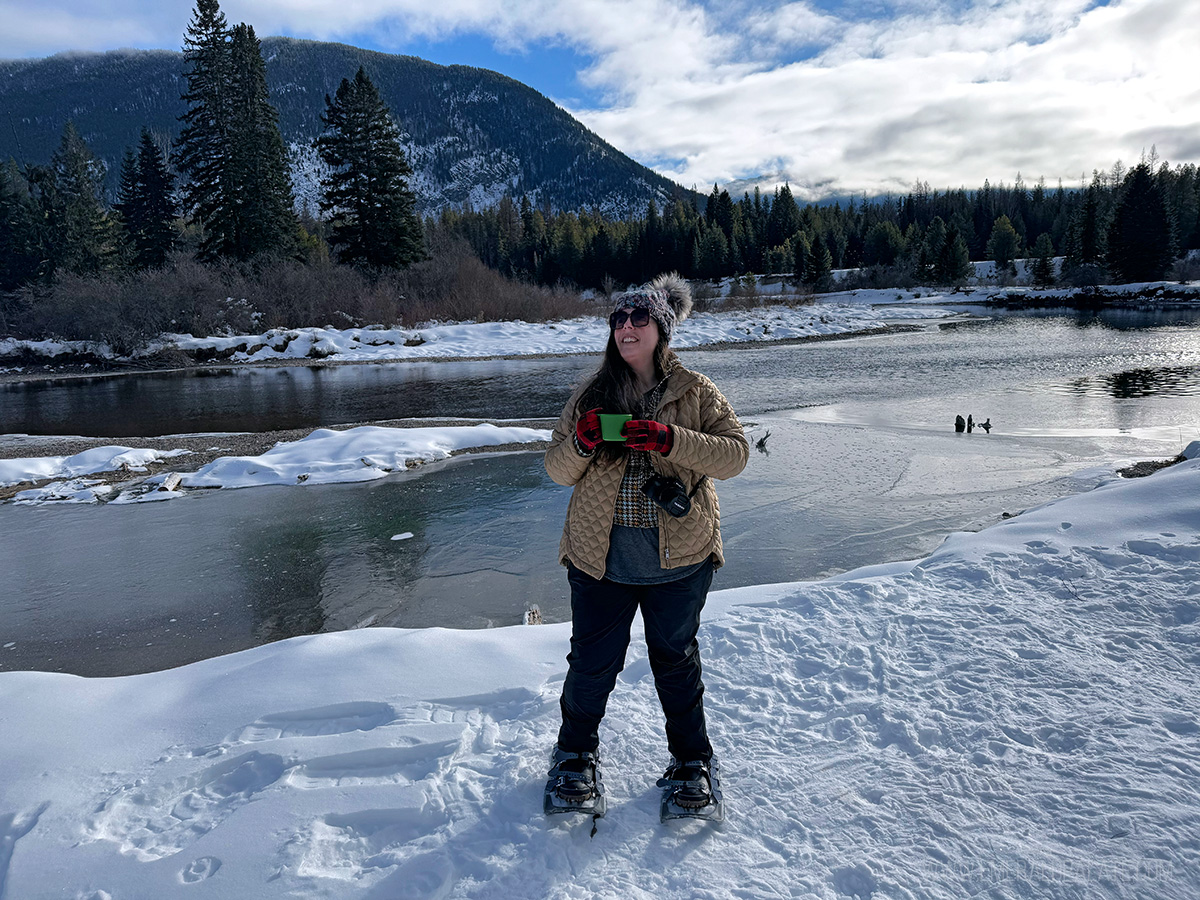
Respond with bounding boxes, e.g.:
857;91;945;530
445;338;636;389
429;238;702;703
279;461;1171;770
546;274;750;814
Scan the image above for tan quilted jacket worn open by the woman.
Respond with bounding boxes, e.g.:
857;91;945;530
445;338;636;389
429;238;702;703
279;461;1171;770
546;366;750;578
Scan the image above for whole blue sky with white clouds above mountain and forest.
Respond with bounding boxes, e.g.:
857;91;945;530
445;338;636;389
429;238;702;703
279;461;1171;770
0;0;1200;199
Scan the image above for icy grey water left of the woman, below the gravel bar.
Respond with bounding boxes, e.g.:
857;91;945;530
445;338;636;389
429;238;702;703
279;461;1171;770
0;454;556;676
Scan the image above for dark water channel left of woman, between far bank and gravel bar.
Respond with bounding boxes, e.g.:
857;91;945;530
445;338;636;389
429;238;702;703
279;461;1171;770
0;356;596;438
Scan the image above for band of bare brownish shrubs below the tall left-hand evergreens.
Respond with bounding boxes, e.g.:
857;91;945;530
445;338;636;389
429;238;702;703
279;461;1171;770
0;244;596;355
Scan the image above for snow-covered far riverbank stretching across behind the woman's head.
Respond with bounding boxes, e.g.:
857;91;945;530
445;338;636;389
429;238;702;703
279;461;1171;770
9;282;1200;380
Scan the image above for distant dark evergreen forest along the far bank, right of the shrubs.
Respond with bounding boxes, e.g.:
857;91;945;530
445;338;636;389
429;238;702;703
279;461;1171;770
428;156;1200;289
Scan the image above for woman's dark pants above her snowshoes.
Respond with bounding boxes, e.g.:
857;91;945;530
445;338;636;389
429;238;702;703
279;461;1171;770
558;560;713;760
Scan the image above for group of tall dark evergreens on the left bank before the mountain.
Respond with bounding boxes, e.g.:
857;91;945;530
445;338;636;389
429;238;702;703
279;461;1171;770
0;0;426;300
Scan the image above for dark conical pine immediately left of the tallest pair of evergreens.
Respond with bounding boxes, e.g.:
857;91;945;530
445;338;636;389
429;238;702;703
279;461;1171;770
116;128;179;269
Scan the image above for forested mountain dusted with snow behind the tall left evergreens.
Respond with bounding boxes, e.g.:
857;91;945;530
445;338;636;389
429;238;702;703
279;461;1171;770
0;37;698;216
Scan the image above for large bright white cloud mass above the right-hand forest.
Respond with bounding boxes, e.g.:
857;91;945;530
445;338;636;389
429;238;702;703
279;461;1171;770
564;0;1200;193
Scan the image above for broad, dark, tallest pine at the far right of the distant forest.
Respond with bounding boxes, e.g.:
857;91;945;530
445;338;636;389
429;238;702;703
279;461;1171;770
1108;163;1175;283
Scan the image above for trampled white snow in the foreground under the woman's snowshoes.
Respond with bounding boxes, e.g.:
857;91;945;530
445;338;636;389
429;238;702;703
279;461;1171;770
0;448;1200;900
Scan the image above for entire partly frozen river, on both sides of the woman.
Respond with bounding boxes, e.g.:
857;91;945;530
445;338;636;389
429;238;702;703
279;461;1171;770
0;313;1200;674
